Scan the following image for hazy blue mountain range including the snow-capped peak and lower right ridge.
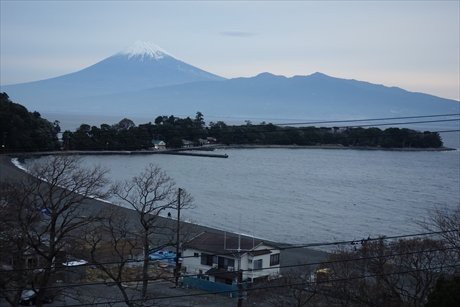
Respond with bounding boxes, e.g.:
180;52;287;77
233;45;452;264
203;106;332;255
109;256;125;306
1;42;460;119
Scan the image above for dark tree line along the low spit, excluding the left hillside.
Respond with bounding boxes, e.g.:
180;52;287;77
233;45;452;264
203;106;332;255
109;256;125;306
63;112;443;150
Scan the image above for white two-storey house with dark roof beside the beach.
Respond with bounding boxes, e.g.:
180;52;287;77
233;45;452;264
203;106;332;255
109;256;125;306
182;232;280;284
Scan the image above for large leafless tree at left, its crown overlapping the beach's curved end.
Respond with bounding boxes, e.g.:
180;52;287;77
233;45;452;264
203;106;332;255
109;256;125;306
0;156;106;306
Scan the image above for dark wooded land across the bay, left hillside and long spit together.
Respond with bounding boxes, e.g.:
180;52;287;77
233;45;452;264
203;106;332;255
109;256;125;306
0;93;443;152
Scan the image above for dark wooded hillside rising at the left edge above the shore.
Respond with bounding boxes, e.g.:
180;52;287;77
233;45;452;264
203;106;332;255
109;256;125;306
0;93;59;152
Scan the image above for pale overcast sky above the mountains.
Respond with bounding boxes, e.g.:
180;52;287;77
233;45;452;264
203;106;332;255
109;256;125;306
0;0;460;100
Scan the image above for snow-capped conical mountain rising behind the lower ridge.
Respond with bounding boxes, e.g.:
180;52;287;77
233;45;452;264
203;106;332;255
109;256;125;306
1;41;224;111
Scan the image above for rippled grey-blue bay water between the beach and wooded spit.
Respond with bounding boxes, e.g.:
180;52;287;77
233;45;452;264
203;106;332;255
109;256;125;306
24;149;460;244
